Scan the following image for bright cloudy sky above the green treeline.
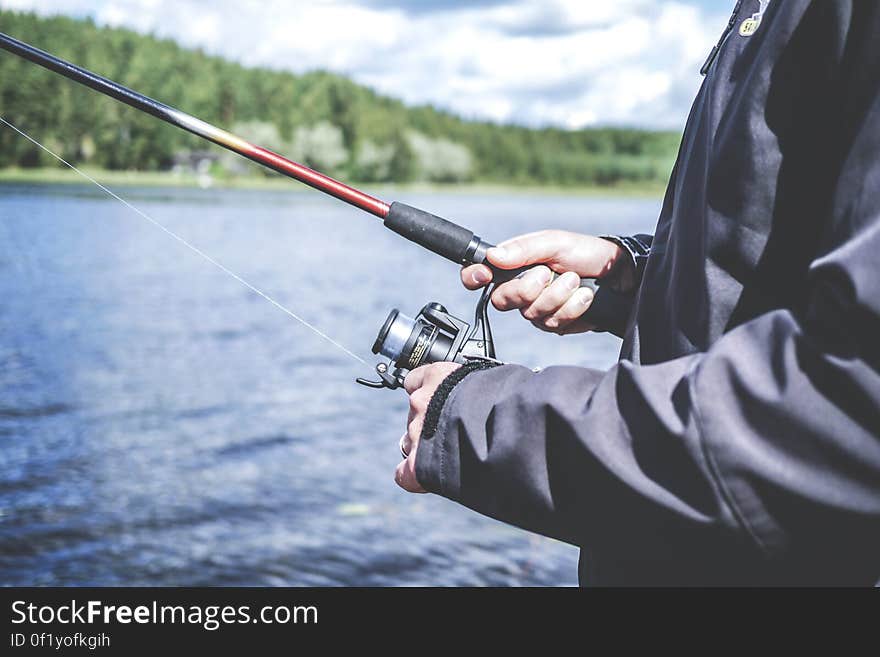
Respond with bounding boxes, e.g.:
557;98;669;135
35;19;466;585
0;0;734;128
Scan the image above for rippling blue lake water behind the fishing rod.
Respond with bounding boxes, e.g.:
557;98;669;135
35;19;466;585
0;183;659;586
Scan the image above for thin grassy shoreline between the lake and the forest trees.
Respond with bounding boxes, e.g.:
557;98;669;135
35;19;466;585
0;168;664;197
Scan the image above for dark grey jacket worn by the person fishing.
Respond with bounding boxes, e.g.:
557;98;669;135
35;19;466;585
417;0;880;585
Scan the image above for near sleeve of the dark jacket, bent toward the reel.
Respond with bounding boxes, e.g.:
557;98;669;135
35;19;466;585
416;53;880;570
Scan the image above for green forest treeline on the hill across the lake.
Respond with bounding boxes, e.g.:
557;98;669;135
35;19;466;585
0;10;680;185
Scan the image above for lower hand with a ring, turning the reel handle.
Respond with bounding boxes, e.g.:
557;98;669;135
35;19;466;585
394;362;461;493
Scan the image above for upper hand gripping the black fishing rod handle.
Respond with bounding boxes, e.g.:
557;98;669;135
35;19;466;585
461;230;623;335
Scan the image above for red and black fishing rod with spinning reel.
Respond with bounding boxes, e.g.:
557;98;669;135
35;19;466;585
0;32;628;389
